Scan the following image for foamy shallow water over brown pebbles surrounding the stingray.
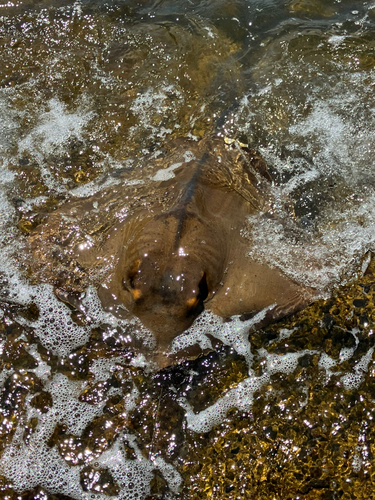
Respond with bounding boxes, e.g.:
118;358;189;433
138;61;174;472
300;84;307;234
0;0;375;500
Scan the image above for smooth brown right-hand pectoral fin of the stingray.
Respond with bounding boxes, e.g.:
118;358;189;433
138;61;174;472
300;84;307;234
206;259;314;326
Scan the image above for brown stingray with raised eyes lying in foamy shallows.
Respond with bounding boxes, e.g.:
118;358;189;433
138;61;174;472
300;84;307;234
29;136;314;368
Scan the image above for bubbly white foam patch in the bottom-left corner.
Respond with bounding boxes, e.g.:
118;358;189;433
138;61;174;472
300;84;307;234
0;362;153;500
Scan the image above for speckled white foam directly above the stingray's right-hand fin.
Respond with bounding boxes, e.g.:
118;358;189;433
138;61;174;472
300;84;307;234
244;191;375;296
